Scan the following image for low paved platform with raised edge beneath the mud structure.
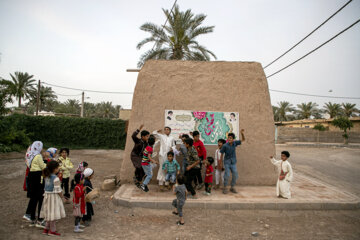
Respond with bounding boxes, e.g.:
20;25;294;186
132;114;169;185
113;174;360;210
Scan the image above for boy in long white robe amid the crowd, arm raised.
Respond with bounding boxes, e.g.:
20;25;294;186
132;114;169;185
153;127;176;191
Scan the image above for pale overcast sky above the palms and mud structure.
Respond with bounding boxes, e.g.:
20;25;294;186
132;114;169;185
0;0;360;108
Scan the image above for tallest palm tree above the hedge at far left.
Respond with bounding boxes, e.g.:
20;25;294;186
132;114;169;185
4;72;35;108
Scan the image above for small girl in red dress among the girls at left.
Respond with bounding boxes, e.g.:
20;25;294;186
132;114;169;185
73;173;86;233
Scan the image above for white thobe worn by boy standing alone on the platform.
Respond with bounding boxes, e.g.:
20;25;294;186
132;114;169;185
271;158;293;198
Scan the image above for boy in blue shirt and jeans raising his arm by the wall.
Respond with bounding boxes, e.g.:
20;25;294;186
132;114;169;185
220;129;245;194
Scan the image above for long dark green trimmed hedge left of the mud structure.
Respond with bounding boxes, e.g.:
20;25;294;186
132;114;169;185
0;114;126;149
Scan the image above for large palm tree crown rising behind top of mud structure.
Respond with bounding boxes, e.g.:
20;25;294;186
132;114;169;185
136;5;216;67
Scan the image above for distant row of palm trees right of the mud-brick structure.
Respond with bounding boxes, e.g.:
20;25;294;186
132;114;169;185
272;101;360;121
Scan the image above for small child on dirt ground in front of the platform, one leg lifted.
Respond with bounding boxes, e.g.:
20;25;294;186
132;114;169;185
172;175;187;225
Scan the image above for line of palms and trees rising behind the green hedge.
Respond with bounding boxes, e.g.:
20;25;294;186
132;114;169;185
0;72;121;118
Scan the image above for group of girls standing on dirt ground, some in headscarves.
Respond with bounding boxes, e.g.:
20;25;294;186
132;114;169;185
23;141;94;236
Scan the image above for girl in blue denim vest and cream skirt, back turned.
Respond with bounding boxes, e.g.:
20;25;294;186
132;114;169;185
40;161;66;236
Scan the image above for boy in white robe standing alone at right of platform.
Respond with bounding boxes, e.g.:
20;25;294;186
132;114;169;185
270;151;293;199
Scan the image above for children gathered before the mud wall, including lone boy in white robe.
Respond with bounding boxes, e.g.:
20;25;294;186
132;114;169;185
131;125;292;225
